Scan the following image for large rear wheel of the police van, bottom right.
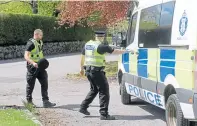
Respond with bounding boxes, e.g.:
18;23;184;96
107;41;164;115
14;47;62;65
166;94;189;126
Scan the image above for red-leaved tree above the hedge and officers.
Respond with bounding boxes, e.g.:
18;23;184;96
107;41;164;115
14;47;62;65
57;1;129;26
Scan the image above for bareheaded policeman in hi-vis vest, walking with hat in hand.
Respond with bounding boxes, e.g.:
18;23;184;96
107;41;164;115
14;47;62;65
24;29;56;107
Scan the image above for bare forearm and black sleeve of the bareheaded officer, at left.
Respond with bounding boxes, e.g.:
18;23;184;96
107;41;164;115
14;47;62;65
24;41;35;64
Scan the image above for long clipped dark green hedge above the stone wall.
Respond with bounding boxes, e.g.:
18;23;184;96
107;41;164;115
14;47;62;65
0;13;93;45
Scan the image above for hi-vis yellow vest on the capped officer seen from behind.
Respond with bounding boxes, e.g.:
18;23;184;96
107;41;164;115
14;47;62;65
84;40;105;67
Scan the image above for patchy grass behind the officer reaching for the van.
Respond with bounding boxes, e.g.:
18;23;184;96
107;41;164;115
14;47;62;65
66;61;118;79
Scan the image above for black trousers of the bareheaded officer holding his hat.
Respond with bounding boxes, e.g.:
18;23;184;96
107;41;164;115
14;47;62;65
26;64;49;101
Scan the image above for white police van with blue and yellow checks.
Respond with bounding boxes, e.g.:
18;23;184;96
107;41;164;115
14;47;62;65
118;0;197;126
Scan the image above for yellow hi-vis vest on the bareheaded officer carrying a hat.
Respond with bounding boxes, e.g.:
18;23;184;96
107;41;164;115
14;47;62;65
30;39;44;62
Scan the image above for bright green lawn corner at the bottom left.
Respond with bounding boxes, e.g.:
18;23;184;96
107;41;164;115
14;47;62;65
0;109;38;126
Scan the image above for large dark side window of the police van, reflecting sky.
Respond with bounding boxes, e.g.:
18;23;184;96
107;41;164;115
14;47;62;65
138;1;175;48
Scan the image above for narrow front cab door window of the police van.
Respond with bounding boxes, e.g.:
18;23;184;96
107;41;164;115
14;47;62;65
127;12;138;45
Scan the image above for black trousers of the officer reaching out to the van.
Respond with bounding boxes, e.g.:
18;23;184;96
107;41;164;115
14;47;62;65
81;70;110;115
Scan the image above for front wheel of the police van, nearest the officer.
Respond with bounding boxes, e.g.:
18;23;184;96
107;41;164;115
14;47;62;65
120;80;131;105
